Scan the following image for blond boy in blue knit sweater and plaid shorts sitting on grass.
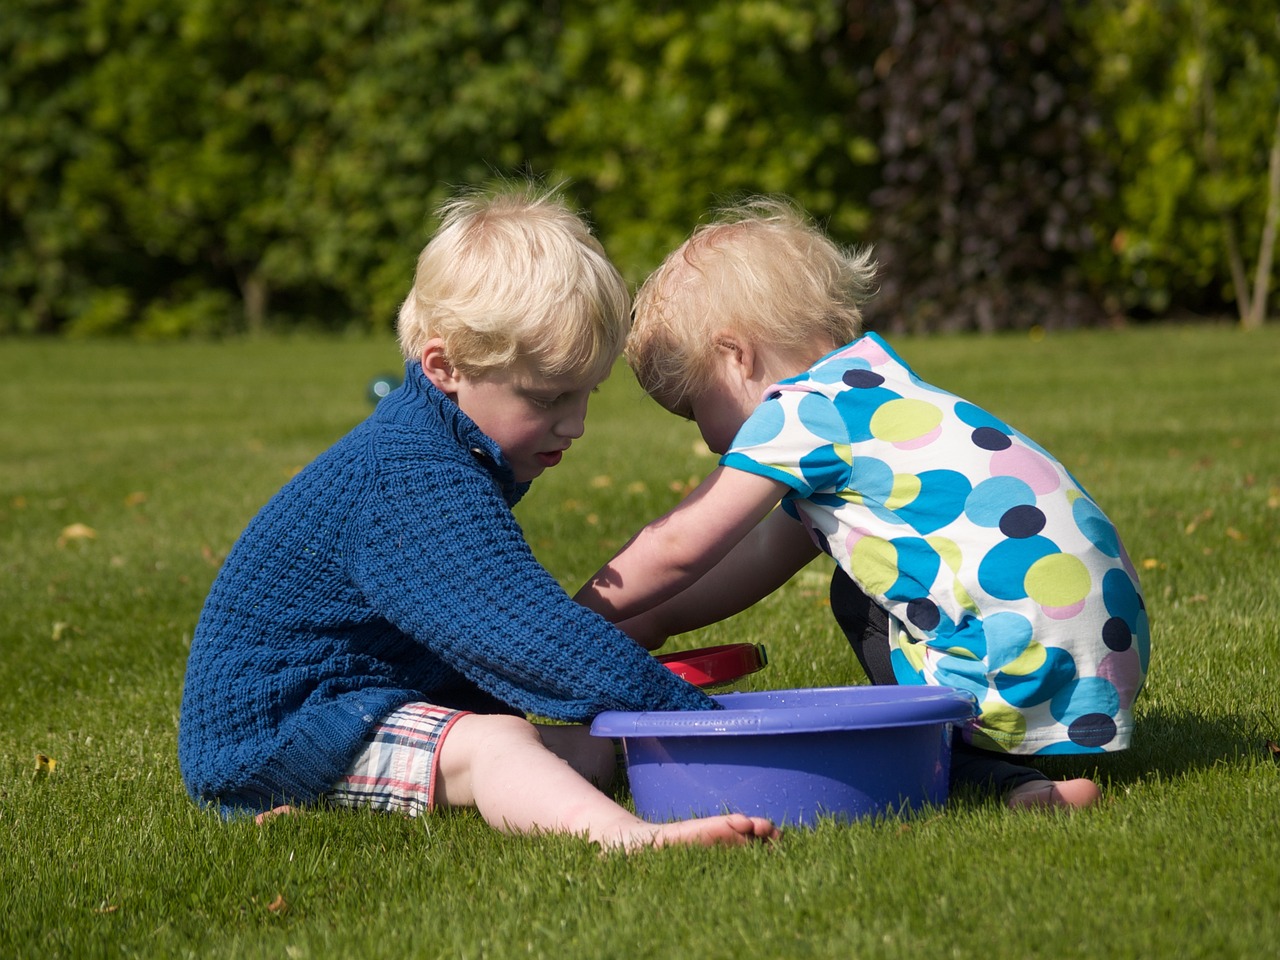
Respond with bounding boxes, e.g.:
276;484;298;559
178;187;777;849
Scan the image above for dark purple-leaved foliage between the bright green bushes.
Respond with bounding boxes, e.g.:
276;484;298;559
849;0;1107;330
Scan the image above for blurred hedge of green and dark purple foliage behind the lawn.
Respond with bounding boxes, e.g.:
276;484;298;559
0;0;1280;338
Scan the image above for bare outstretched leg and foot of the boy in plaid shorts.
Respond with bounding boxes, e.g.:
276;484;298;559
435;713;778;850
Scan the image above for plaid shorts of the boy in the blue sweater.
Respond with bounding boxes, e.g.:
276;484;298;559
325;703;467;817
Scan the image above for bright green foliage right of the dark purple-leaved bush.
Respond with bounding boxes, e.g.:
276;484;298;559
1087;0;1280;327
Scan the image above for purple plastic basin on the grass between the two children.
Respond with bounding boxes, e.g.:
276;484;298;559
591;686;977;826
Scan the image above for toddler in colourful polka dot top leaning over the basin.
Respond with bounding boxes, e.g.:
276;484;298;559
576;201;1149;808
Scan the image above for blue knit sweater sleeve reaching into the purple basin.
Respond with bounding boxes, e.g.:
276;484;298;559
347;442;714;722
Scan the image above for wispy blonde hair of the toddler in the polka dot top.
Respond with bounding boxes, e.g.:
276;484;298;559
626;197;876;407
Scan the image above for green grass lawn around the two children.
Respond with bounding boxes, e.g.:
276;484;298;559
0;326;1280;960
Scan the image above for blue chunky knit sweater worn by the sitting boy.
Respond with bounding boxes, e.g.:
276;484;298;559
178;362;713;813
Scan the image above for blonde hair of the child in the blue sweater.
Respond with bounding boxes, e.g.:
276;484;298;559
397;183;631;379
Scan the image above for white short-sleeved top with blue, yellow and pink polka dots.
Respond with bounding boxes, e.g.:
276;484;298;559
722;334;1151;754
